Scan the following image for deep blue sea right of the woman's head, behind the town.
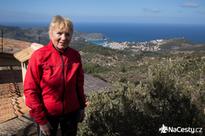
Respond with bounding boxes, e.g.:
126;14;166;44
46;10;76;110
75;23;205;43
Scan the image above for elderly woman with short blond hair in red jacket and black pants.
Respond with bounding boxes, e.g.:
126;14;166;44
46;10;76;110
24;16;85;136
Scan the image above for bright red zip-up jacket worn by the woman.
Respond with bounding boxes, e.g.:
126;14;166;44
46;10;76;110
24;42;85;125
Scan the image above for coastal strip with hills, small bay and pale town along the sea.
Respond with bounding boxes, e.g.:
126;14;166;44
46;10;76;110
72;32;194;52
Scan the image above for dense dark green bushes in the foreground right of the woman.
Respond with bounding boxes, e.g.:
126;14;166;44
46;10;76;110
79;55;205;136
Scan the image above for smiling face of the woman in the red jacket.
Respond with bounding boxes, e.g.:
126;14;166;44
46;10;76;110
50;29;72;51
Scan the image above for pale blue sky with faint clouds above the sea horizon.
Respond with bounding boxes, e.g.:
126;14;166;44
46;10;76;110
0;0;205;25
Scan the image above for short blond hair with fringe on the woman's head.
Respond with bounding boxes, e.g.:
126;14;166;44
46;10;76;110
49;15;73;33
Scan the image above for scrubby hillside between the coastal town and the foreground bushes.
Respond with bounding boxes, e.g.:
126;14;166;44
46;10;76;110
72;43;205;83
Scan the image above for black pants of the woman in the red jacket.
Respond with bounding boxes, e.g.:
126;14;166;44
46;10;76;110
38;112;78;136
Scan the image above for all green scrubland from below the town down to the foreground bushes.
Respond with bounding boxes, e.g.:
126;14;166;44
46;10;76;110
70;44;205;136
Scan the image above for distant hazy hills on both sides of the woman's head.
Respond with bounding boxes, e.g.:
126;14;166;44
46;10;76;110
0;25;104;44
